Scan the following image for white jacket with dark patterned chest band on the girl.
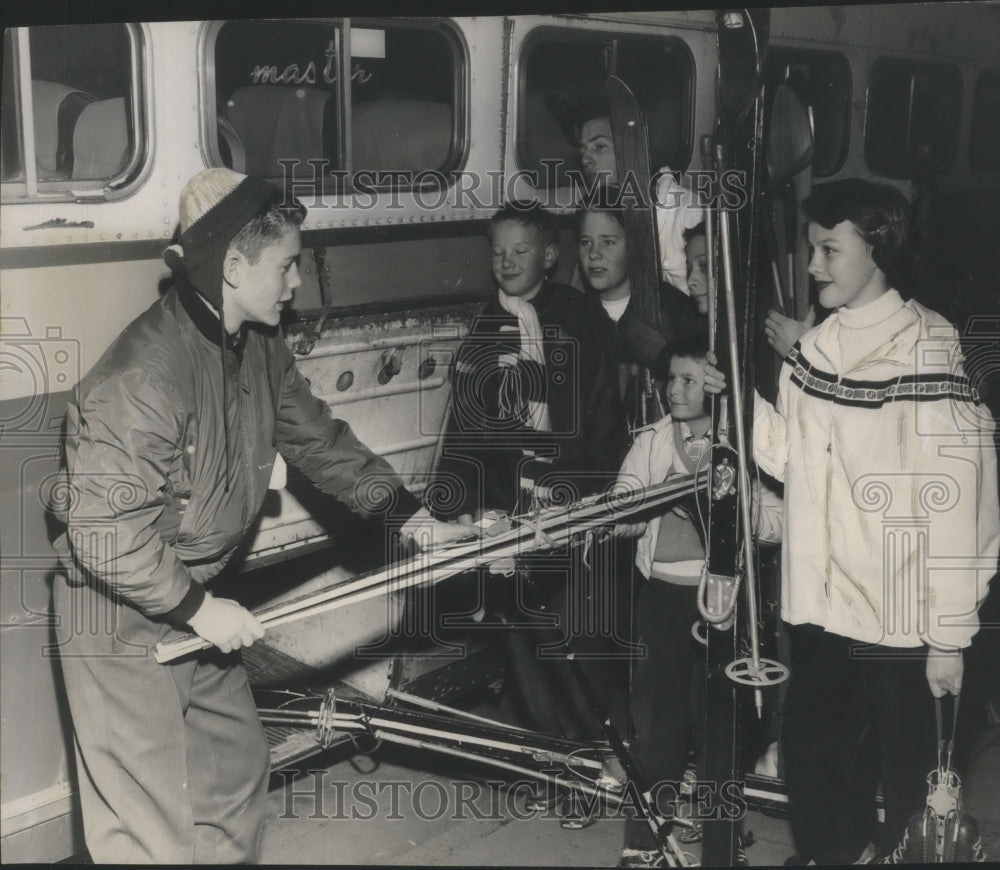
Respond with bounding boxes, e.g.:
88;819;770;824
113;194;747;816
754;290;1000;649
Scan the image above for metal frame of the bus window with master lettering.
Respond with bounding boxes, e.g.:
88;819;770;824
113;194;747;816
203;16;471;198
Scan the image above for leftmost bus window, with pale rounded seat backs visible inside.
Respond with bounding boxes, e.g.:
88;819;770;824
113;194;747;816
2;24;142;200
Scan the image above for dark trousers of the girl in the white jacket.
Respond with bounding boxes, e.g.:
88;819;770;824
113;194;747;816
782;625;937;864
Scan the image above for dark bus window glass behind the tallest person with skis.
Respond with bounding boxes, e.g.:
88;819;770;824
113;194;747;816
517;27;694;188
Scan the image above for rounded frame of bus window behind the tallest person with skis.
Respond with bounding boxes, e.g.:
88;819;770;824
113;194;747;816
514;24;698;190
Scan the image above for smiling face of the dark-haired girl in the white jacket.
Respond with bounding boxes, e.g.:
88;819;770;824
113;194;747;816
809;221;888;308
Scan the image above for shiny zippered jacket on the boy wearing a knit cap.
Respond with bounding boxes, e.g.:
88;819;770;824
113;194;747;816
52;278;419;624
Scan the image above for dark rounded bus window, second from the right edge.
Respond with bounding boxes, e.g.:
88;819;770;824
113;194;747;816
865;57;962;178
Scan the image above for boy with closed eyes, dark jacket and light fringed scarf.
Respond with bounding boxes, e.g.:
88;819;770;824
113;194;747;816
440;203;625;519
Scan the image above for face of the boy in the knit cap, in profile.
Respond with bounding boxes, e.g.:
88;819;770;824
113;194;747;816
223;226;302;331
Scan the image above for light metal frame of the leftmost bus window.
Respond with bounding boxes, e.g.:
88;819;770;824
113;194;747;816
0;21;149;205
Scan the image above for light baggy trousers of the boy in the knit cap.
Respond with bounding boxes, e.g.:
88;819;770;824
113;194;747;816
54;577;269;864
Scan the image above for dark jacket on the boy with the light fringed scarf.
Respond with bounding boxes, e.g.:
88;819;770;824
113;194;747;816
435;281;627;517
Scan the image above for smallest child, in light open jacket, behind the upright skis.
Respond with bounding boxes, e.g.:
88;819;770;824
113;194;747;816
615;336;782;867
